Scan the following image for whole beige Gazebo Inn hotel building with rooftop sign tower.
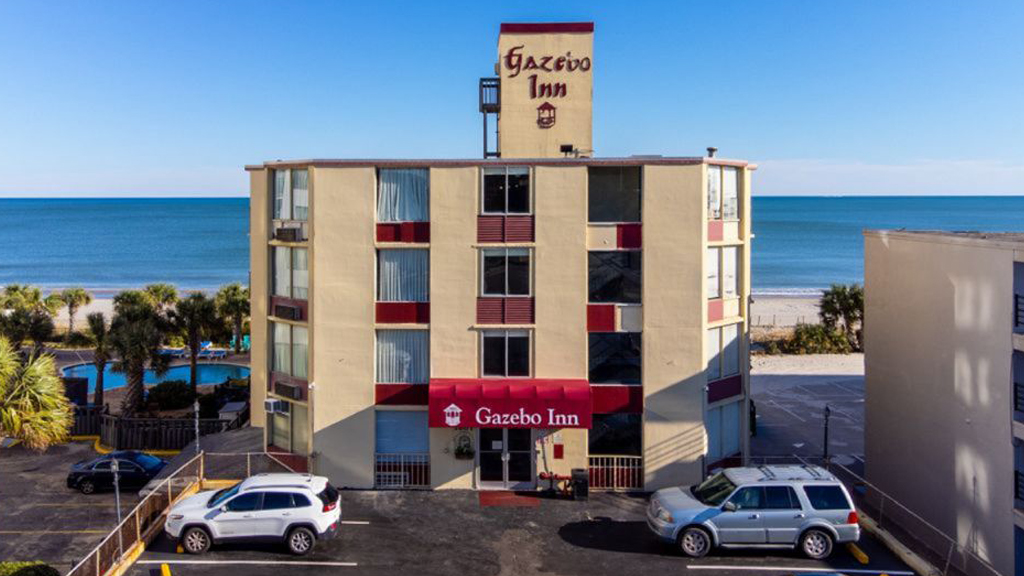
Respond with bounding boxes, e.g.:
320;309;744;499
247;23;755;490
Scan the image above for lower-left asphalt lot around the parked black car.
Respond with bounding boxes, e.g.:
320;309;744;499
0;442;138;572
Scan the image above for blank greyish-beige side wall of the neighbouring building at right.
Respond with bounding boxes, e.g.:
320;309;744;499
864;233;1014;574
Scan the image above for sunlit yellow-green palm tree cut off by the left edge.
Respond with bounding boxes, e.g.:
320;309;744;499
0;338;75;450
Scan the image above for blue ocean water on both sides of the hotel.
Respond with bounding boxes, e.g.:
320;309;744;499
0;196;1024;294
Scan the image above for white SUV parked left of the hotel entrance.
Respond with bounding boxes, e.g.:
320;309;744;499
164;474;341;556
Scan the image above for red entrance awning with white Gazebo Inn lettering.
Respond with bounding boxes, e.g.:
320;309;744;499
429;378;591;428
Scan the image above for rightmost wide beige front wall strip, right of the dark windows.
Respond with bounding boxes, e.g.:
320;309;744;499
643;166;707;490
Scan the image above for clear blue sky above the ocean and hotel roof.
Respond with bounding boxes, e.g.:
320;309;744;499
0;0;1024;196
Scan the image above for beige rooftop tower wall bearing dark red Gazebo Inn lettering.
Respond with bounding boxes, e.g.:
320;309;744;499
498;33;594;158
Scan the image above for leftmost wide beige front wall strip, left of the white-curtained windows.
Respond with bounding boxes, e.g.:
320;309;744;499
309;167;377;488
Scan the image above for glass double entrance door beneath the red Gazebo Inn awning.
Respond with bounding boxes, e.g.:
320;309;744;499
477;428;536;490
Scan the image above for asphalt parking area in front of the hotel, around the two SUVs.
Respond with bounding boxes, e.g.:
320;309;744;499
130;491;912;576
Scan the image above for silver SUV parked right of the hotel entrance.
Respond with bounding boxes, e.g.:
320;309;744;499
647;465;860;560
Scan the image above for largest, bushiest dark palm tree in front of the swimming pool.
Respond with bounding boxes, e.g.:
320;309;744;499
109;291;168;417
